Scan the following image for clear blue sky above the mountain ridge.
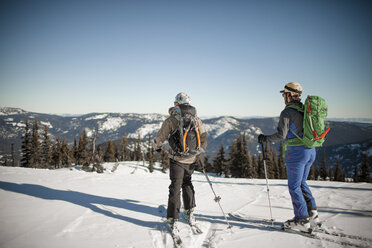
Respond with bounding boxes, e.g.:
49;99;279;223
0;0;372;118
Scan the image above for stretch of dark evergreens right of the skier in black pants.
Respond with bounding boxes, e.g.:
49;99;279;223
198;134;371;182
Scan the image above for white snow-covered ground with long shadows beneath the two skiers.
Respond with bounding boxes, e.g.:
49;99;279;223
0;162;372;248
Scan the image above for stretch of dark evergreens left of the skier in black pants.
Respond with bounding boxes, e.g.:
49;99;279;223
16;120;155;173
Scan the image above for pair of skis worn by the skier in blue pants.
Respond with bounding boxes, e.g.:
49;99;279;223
229;213;369;247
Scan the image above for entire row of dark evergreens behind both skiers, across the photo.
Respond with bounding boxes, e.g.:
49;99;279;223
3;120;371;182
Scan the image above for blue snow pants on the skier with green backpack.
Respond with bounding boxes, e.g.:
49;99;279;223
285;146;316;219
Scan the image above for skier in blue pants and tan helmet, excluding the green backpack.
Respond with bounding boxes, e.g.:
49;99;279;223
258;82;319;232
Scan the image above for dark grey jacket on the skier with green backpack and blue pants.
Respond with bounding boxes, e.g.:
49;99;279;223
266;102;304;142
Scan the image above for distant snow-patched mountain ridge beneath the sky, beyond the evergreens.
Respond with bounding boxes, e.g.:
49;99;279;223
0;107;372;176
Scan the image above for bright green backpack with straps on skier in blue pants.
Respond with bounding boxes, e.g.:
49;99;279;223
286;96;330;148
